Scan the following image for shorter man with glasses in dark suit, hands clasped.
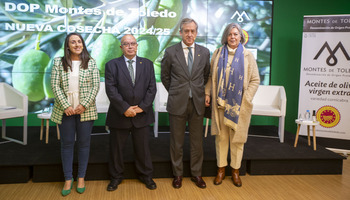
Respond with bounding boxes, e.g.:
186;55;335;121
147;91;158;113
105;35;157;191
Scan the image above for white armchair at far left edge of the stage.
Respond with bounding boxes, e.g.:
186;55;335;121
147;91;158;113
0;82;28;145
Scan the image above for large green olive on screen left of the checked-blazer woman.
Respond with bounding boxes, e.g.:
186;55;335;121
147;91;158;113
12;49;50;102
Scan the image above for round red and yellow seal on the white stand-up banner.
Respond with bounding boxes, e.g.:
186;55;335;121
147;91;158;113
316;105;340;128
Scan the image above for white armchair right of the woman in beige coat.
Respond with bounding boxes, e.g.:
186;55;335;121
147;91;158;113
252;85;287;143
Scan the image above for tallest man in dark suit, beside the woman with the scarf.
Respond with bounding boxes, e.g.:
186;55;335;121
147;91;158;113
161;18;210;188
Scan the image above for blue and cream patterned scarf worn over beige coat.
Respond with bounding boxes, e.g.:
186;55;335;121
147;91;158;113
217;43;244;130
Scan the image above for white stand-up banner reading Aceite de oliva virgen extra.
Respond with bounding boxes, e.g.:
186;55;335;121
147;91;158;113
298;14;350;140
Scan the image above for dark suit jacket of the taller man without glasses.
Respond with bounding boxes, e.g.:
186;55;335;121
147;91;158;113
161;42;210;115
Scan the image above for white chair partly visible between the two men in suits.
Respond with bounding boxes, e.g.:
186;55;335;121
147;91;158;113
153;82;168;137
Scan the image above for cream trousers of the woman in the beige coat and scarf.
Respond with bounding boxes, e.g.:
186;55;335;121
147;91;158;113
215;109;244;169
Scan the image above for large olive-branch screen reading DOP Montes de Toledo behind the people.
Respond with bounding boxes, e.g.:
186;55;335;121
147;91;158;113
0;0;272;113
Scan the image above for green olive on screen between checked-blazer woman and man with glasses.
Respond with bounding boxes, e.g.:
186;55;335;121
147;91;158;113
91;33;123;77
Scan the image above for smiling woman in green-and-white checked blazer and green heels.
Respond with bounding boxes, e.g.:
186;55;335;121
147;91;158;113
51;33;100;196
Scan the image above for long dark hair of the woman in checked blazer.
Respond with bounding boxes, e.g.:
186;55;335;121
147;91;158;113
61;33;90;72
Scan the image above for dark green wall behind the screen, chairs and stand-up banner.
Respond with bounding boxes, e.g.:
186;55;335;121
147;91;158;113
2;0;350;133
